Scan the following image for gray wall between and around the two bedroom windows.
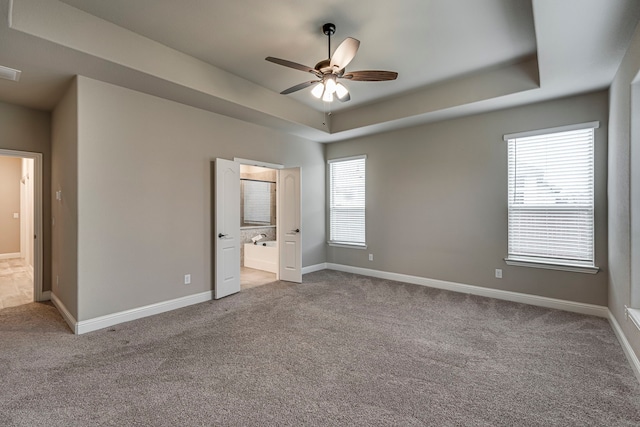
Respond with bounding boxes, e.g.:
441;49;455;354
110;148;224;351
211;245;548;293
326;91;608;305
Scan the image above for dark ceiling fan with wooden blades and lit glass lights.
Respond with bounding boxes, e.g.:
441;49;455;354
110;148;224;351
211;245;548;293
265;23;398;102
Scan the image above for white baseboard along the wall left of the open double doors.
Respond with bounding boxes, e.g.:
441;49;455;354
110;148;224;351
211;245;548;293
75;291;213;335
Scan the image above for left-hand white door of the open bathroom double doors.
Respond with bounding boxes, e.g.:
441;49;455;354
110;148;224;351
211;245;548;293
213;159;240;299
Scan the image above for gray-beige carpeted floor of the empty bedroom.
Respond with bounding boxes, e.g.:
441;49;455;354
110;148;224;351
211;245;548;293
0;271;640;426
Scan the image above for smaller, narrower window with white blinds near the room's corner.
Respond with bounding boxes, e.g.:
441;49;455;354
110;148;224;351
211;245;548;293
328;156;367;247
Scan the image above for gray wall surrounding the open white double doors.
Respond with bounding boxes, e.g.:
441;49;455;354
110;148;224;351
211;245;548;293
77;77;325;320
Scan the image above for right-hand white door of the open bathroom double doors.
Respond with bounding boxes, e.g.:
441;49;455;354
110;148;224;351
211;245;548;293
278;168;302;283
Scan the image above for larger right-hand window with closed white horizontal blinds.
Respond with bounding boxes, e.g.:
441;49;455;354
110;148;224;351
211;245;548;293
504;122;598;273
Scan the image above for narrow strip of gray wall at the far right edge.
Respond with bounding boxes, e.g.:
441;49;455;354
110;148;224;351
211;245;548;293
609;20;640;357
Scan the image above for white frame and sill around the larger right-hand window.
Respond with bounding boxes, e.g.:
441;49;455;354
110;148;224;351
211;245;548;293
503;121;600;274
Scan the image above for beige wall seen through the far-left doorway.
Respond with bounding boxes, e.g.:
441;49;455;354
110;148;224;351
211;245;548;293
0;156;22;254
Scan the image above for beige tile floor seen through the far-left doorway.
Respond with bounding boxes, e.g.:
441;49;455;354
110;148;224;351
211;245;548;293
0;258;33;309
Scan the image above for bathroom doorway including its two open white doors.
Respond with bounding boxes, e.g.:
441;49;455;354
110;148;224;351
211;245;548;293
212;158;302;299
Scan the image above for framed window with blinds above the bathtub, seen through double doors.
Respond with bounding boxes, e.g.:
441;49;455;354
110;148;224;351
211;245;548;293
240;179;276;228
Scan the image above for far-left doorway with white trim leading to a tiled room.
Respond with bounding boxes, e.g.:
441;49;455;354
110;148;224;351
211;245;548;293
0;150;42;309
